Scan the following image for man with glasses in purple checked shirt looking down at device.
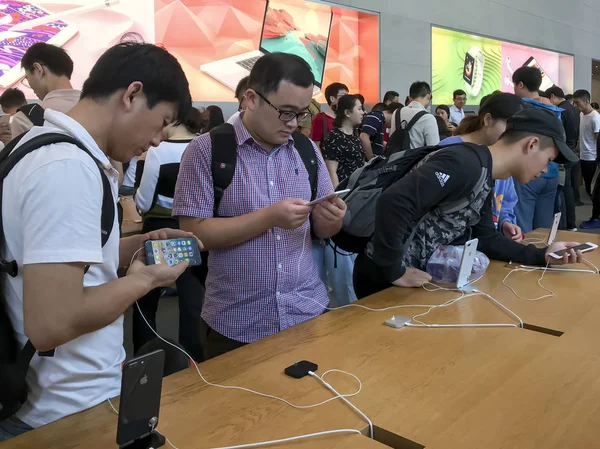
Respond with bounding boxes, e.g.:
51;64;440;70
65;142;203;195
173;53;346;358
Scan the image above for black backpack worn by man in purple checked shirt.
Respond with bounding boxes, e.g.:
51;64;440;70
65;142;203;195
194;123;319;285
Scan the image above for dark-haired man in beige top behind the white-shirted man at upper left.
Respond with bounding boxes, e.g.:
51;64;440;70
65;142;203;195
10;42;81;137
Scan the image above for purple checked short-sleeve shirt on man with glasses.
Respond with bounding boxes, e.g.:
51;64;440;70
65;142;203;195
173;114;333;343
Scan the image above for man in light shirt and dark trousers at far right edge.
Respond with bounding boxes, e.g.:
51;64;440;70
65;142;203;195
573;89;600;229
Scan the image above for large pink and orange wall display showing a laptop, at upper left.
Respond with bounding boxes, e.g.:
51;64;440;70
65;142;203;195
0;0;379;103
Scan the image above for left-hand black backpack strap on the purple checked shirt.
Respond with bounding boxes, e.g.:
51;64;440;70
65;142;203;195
209;123;237;217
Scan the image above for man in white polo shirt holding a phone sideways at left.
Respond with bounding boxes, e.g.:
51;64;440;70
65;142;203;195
0;43;191;441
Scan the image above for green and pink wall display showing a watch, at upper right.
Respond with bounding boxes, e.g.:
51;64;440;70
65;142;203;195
431;27;574;105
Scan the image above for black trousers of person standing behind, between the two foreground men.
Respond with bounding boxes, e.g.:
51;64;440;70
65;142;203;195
133;218;204;362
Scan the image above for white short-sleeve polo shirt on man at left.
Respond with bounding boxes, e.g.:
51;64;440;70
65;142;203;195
1;109;125;427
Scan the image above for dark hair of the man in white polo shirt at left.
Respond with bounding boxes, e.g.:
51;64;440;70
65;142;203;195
81;42;192;121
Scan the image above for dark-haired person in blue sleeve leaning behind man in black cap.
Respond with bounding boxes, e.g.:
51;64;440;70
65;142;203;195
440;93;524;241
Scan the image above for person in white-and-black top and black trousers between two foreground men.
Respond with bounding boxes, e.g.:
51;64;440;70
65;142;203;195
133;108;203;361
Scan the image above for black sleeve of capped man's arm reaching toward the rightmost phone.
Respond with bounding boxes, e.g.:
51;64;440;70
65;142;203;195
472;191;546;265
